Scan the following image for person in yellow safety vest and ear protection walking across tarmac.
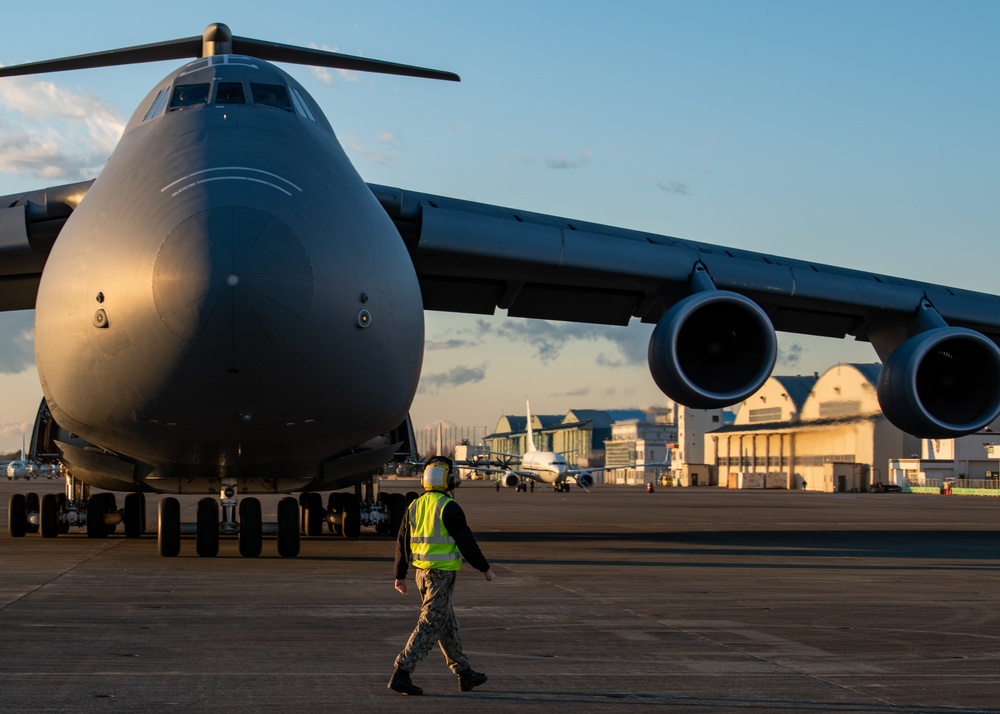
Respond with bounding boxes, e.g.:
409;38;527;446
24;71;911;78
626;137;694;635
389;456;496;694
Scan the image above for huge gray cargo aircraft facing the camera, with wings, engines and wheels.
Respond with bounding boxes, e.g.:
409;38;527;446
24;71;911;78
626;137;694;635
0;24;1000;556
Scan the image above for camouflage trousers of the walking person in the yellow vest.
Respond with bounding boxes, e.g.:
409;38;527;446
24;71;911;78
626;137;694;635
396;568;469;674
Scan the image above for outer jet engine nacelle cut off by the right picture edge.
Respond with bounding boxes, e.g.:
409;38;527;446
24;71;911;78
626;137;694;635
878;327;1000;438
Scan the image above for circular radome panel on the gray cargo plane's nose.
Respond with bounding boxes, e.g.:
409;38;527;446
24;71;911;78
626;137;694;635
153;206;313;351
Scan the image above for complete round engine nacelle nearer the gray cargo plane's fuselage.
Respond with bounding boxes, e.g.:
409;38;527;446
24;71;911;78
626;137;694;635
649;290;778;409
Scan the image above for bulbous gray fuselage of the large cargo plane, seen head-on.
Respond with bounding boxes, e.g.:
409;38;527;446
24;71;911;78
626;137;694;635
35;55;423;490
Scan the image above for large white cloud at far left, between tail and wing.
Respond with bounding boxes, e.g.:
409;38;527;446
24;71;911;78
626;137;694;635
0;77;125;180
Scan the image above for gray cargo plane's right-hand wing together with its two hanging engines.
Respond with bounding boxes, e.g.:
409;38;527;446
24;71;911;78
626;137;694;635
369;184;1000;438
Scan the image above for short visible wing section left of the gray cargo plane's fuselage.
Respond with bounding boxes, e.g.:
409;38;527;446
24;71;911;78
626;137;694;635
0;180;94;311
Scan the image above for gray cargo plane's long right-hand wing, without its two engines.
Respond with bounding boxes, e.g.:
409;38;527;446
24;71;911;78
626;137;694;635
369;184;1000;346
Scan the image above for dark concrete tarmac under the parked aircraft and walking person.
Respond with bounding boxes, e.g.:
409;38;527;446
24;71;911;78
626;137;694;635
0;480;1000;714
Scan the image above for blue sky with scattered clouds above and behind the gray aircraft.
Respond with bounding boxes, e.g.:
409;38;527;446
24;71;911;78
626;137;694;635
0;0;1000;448
